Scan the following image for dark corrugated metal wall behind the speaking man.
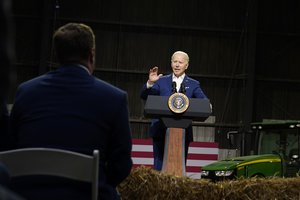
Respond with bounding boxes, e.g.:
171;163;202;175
10;0;300;150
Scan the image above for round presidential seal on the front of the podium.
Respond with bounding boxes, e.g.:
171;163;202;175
168;93;190;113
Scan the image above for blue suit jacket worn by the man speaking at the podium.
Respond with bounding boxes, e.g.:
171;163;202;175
141;74;207;141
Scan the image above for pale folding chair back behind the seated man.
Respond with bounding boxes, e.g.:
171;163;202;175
0;148;99;200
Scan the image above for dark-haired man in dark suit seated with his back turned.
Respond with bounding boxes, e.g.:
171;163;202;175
11;23;132;200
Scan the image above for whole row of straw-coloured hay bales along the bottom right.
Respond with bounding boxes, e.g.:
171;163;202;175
118;167;300;200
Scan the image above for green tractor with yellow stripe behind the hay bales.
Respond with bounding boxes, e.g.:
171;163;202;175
201;120;300;181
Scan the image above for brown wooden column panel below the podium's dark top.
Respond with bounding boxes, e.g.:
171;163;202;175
162;128;185;176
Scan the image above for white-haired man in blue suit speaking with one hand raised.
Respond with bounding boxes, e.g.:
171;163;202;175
141;51;207;170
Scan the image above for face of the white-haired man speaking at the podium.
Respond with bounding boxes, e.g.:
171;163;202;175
171;53;188;77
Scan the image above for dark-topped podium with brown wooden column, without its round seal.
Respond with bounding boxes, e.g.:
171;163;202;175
144;95;212;176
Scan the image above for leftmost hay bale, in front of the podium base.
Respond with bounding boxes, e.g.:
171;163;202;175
118;166;221;200
